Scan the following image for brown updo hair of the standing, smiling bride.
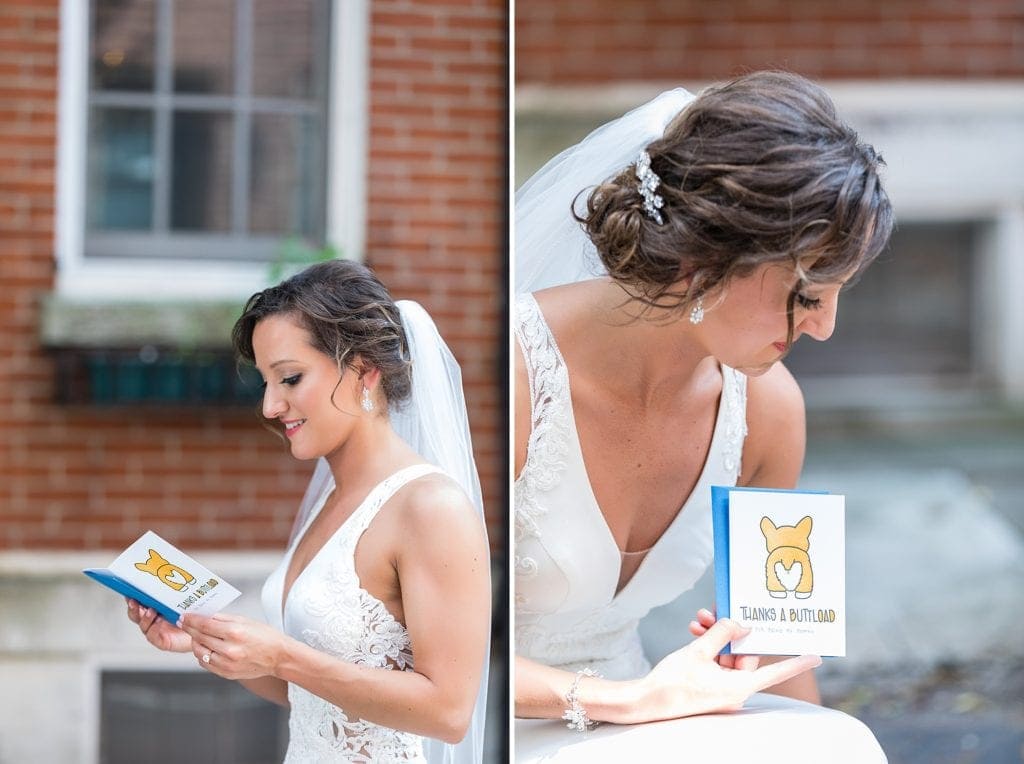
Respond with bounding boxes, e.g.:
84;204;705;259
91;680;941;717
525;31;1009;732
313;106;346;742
231;260;413;413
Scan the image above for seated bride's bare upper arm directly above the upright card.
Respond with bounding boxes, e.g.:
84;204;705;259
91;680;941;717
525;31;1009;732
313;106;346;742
740;364;806;487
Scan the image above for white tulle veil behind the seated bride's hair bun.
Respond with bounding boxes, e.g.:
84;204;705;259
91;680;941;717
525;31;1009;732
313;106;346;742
513;88;693;294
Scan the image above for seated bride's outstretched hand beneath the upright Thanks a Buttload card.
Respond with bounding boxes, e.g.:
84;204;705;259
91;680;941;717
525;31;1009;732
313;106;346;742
638;619;821;720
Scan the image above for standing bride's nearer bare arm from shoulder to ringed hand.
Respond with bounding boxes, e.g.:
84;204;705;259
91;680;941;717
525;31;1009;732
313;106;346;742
184;487;490;742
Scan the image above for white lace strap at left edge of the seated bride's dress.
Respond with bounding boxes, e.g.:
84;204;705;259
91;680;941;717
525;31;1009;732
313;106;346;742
514;295;571;596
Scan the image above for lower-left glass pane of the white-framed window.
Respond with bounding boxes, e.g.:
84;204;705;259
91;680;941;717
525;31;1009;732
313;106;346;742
86;108;154;230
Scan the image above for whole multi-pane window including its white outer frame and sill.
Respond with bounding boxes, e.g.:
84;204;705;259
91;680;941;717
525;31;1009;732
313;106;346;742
55;0;370;296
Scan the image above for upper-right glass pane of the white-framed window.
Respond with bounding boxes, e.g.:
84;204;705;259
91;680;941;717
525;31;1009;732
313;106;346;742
252;0;328;98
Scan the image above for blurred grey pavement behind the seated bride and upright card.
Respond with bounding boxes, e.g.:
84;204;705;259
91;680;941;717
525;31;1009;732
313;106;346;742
643;410;1024;764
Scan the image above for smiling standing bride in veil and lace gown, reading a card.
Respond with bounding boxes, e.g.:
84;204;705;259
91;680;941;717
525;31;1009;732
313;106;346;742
128;260;490;764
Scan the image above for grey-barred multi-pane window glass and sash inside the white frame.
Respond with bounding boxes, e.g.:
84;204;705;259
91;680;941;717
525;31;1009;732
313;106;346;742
84;0;330;260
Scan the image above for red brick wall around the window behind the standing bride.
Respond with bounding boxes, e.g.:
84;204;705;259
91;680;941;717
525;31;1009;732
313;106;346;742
0;0;506;549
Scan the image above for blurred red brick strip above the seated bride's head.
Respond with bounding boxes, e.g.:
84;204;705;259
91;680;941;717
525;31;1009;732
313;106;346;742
515;0;1024;85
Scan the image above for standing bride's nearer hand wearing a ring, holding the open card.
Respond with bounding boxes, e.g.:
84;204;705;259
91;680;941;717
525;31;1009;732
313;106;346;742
181;613;285;679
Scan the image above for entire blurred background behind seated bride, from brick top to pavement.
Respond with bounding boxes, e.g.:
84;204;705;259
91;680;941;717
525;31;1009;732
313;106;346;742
514;0;1024;764
